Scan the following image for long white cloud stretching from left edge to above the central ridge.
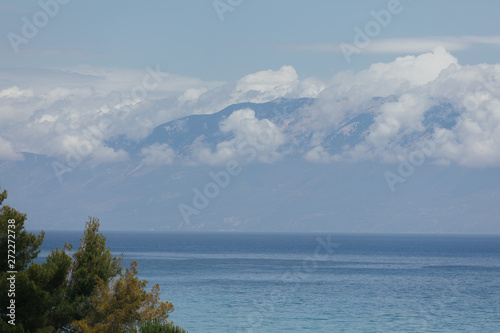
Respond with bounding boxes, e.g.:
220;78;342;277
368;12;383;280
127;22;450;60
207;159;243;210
0;66;324;160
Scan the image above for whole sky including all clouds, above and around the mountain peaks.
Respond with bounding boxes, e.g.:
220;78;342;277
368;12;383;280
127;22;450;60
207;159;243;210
0;0;500;231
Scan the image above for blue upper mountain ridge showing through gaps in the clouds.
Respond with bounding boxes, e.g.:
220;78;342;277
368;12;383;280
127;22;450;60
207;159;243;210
106;96;460;162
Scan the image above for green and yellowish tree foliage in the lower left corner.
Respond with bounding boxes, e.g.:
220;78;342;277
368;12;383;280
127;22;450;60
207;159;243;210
0;185;186;333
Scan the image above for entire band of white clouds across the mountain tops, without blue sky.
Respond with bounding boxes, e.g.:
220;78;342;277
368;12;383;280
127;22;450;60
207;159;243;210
0;47;500;167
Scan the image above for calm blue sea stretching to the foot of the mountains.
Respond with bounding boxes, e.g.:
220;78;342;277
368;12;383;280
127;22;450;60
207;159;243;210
38;231;500;333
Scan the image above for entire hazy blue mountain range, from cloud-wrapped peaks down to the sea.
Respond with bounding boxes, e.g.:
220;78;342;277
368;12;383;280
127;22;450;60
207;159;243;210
0;96;500;232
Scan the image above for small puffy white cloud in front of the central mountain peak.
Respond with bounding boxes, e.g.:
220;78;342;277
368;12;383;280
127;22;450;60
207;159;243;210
193;109;285;165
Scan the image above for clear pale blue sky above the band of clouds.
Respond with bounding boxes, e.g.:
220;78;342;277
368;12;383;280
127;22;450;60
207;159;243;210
0;0;500;80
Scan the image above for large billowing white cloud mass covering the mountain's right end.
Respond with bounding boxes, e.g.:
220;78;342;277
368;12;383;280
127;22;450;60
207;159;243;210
304;48;500;167
